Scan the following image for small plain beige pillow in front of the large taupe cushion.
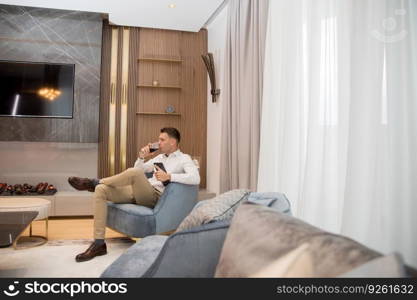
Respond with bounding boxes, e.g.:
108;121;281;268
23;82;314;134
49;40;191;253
250;243;313;278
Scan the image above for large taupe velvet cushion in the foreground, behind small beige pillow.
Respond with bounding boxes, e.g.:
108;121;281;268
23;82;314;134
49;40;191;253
215;203;380;277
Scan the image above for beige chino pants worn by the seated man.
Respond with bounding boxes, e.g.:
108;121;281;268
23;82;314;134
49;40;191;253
94;168;159;239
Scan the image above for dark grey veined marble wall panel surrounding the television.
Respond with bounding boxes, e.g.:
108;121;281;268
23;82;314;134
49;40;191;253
0;5;102;143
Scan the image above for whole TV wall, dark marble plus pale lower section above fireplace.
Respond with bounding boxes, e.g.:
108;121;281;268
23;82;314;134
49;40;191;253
0;5;102;192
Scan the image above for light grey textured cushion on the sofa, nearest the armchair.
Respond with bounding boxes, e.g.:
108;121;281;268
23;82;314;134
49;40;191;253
176;189;250;232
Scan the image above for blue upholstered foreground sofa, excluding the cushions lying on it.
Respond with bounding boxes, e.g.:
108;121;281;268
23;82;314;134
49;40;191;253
101;193;291;278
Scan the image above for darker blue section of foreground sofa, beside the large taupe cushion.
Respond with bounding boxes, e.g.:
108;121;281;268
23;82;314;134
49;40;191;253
143;221;229;277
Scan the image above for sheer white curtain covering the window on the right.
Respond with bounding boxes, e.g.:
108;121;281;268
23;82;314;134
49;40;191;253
258;0;417;266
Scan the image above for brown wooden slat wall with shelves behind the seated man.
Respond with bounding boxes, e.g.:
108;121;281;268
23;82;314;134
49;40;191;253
99;24;207;188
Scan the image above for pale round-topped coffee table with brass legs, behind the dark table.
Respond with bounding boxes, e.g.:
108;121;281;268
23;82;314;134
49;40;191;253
0;197;51;249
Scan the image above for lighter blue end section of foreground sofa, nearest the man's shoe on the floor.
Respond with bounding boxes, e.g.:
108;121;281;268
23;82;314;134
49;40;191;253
101;235;168;277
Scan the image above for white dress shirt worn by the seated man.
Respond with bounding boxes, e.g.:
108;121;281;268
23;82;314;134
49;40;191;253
134;150;200;193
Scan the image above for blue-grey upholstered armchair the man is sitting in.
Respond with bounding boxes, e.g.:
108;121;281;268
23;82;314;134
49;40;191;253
107;182;198;238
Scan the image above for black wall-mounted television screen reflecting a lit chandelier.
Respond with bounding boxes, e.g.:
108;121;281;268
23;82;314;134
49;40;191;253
0;61;74;118
